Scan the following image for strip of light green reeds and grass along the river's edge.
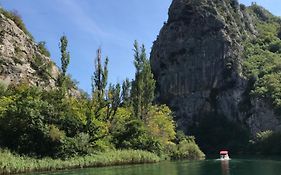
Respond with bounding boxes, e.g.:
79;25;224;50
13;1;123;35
0;150;160;174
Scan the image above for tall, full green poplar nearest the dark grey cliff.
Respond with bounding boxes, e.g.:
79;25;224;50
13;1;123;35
132;41;155;119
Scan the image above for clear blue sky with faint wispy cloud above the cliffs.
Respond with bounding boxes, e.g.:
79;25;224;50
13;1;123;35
0;0;281;92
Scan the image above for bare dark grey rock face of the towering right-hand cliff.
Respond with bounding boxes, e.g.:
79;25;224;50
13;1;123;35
151;0;280;134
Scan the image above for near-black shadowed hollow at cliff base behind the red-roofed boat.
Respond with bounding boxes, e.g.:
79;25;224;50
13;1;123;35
191;113;250;154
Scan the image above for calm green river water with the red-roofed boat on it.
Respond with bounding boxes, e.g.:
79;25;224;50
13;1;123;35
29;159;281;175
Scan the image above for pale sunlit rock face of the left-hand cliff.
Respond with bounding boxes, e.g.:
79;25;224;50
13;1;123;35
0;13;59;88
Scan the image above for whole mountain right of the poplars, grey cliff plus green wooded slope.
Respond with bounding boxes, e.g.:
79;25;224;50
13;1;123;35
150;0;281;151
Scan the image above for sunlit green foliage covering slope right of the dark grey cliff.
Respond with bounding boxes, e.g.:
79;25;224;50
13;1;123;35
243;4;281;113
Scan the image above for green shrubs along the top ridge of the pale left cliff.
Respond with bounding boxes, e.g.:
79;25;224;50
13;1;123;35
0;7;33;40
